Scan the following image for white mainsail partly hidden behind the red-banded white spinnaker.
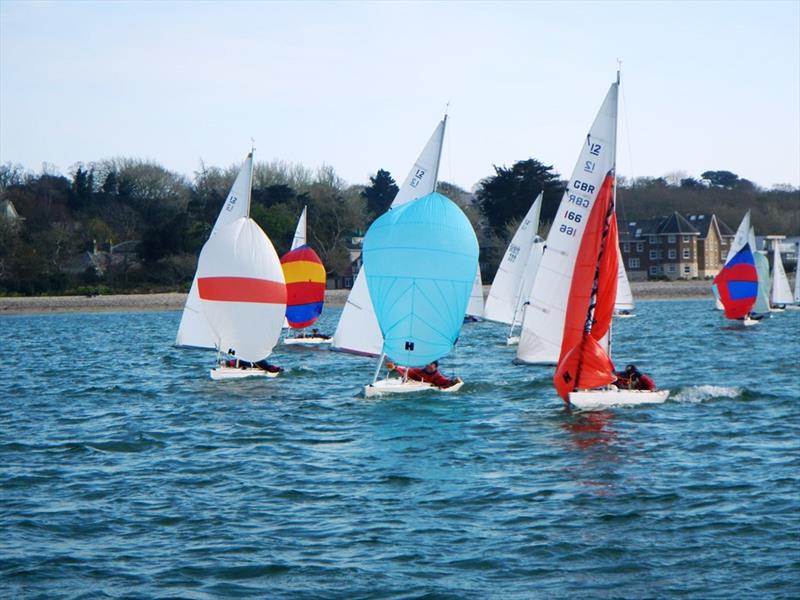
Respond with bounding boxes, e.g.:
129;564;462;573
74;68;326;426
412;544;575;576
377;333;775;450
175;152;253;348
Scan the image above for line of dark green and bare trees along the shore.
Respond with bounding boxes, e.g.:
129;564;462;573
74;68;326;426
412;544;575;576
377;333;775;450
0;158;800;294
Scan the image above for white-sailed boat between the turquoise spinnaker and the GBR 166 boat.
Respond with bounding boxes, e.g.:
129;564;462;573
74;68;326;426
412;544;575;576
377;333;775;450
484;193;544;345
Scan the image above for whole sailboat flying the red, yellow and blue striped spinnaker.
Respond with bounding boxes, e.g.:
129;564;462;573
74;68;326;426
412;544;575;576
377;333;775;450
281;206;330;345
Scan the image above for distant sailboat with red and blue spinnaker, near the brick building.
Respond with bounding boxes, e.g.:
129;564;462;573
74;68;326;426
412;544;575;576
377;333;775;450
714;210;759;326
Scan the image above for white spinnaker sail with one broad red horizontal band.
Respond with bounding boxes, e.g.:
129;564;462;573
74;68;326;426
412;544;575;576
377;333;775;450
197;217;286;361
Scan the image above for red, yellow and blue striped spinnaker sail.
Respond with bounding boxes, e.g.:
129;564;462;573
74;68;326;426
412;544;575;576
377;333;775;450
281;244;325;329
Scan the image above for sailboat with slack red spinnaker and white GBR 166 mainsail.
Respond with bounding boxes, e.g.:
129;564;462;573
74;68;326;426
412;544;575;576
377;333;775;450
548;76;669;408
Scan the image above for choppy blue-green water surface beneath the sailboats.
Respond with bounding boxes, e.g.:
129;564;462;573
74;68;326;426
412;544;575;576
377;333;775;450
0;301;800;598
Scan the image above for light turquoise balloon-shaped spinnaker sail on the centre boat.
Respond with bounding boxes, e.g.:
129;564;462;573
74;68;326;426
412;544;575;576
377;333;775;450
363;192;478;367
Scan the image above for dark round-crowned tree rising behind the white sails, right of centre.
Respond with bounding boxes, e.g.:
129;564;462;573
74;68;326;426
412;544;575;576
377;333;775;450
477;158;564;237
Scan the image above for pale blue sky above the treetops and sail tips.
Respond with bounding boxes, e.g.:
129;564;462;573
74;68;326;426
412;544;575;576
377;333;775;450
0;0;800;189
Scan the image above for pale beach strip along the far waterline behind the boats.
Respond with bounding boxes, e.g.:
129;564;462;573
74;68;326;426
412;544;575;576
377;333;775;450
0;281;712;315
